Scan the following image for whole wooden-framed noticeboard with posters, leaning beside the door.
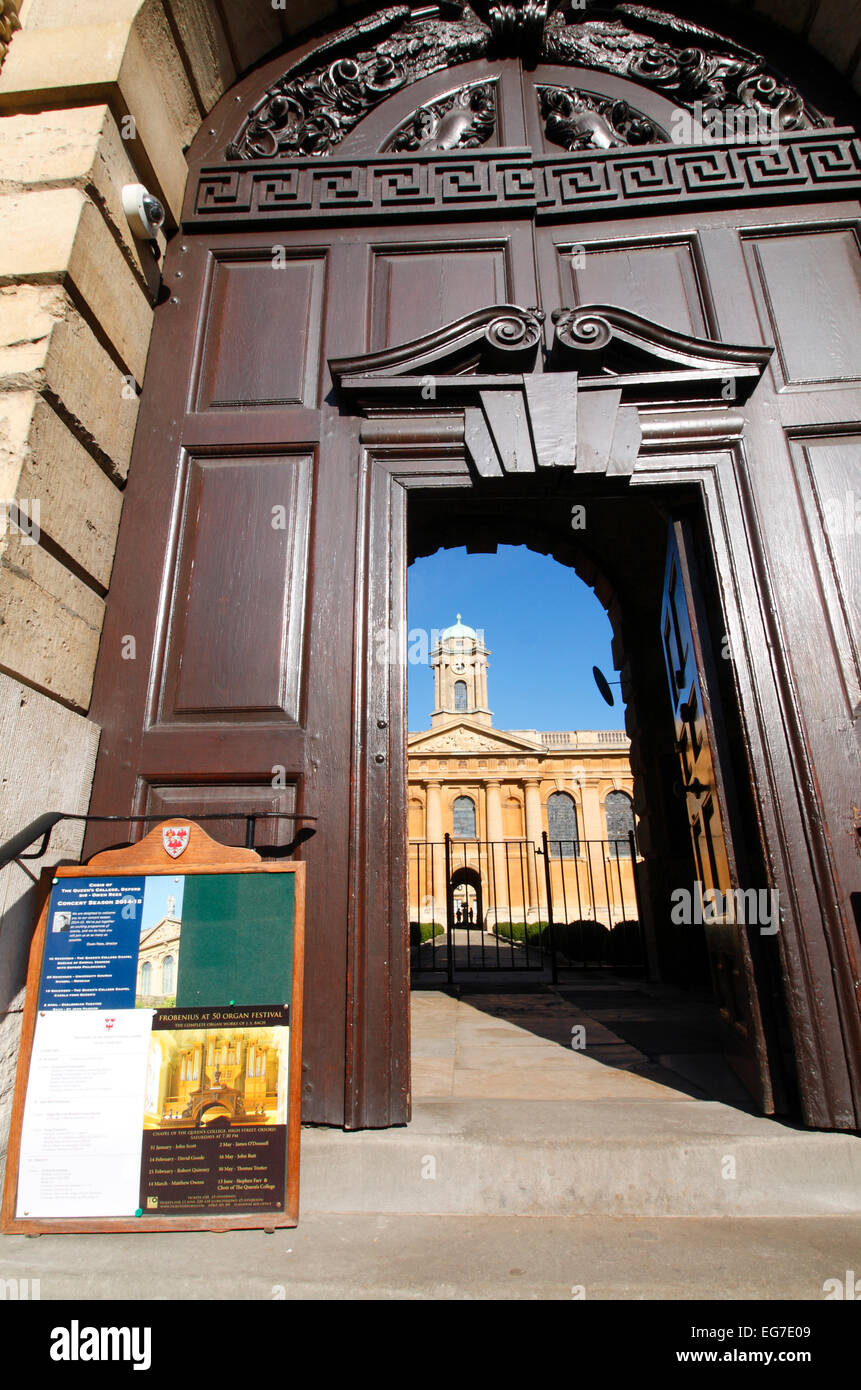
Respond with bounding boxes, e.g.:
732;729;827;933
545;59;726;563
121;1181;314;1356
1;820;305;1234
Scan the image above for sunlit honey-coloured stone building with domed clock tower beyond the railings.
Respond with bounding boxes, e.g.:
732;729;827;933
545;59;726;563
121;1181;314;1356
408;614;636;924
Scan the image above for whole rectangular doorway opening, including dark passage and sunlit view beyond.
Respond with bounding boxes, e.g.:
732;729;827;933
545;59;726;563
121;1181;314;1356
408;484;786;1112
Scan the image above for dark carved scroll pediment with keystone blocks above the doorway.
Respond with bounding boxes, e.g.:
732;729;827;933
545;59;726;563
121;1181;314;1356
330;296;773;478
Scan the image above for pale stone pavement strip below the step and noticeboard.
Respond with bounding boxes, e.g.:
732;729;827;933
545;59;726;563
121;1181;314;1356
0;1212;861;1301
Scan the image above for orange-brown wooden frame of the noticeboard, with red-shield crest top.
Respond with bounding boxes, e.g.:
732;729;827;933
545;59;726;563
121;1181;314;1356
0;817;305;1234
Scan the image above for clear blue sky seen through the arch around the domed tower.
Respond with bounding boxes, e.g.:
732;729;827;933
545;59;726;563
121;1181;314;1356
408;545;625;730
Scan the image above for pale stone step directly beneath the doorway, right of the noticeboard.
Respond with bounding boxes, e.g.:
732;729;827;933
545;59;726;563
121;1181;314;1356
300;1099;861;1218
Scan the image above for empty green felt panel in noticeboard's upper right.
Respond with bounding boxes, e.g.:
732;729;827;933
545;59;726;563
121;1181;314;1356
177;873;295;1008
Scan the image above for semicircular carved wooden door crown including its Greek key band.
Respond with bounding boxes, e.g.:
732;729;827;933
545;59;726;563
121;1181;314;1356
184;3;861;228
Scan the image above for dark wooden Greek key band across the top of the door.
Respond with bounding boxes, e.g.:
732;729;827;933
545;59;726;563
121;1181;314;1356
193;129;861;225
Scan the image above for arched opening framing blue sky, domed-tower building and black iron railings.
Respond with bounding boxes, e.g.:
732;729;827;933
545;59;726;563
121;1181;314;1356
408;546;645;981
